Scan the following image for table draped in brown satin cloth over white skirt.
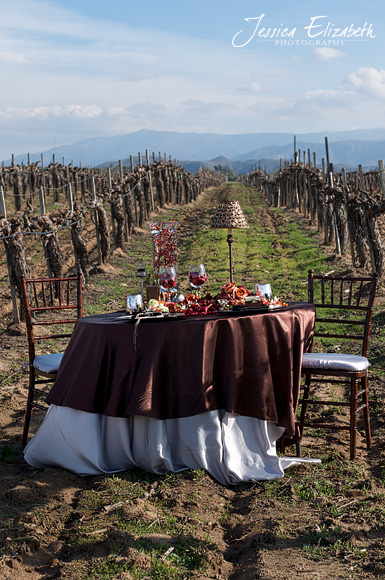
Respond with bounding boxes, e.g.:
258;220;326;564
24;303;315;485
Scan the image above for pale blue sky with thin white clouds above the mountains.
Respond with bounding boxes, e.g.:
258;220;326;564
0;0;385;159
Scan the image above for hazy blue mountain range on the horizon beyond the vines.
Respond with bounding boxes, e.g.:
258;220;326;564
5;129;385;173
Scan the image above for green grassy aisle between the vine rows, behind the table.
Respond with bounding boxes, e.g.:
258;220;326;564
97;183;331;302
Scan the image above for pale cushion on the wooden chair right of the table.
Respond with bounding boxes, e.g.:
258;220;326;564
302;352;370;372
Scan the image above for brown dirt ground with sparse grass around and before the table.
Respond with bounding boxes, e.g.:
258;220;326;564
0;187;385;580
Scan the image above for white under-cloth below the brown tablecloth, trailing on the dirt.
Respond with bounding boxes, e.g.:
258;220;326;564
24;405;319;485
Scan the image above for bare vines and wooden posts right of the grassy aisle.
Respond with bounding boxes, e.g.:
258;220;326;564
245;162;385;278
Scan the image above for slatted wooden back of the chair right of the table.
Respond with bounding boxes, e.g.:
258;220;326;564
308;270;377;357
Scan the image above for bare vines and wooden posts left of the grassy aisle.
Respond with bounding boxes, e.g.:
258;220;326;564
0;156;221;322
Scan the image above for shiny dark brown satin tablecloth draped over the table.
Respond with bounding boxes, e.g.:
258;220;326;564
47;303;315;435
